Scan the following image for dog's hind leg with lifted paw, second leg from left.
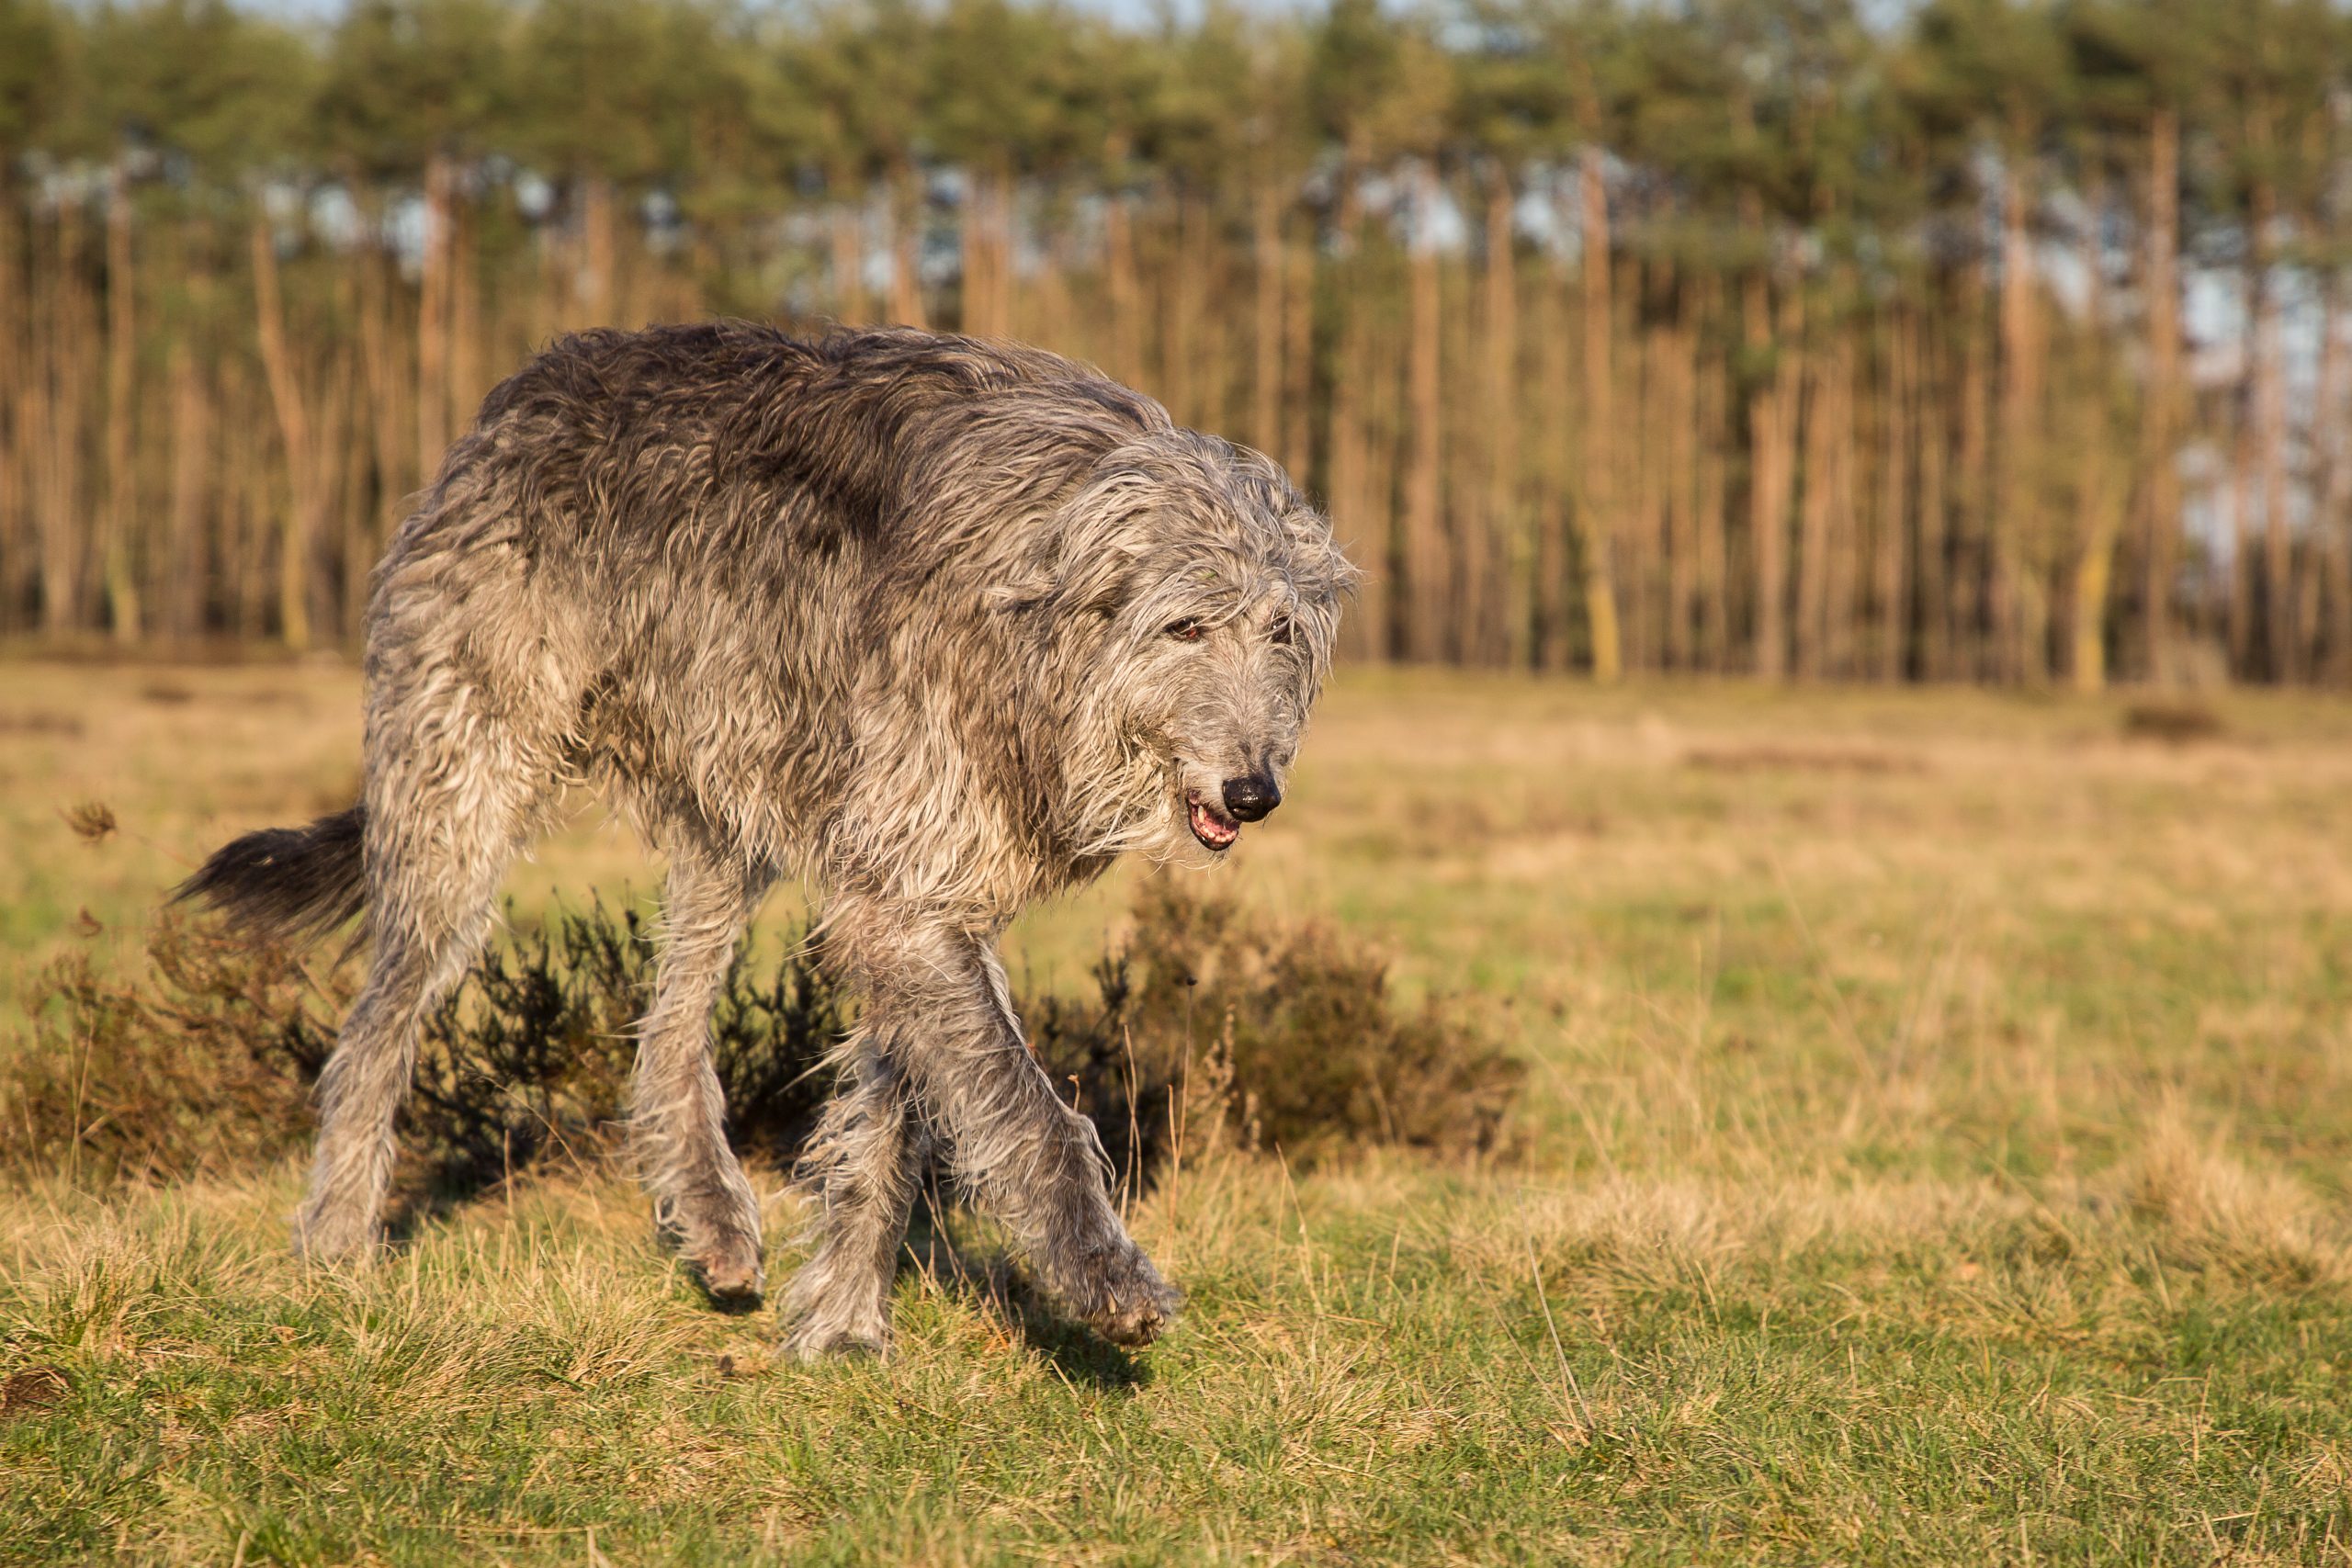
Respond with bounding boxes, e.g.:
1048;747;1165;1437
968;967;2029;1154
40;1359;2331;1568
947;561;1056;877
628;849;776;1304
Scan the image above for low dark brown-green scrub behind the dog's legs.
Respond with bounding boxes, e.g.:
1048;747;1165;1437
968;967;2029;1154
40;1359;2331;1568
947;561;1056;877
0;882;1520;1197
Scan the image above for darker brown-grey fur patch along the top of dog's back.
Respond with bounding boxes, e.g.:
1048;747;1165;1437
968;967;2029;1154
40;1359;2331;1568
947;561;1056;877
393;322;1169;592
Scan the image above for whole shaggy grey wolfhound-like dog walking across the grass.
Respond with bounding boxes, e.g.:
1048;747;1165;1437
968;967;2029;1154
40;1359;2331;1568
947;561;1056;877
181;322;1352;1357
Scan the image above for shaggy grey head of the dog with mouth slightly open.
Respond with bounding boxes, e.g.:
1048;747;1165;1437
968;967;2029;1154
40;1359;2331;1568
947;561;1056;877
1015;430;1355;861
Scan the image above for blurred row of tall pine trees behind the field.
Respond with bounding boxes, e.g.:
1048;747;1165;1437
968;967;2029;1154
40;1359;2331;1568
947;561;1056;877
0;0;2352;689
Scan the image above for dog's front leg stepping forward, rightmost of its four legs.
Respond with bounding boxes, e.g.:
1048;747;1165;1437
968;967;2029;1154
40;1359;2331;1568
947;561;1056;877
804;905;1179;1345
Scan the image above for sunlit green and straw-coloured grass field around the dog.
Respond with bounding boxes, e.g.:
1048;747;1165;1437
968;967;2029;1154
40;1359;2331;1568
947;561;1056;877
0;663;2352;1563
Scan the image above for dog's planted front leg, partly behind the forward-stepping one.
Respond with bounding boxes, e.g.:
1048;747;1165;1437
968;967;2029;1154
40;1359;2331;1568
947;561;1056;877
783;1030;929;1361
